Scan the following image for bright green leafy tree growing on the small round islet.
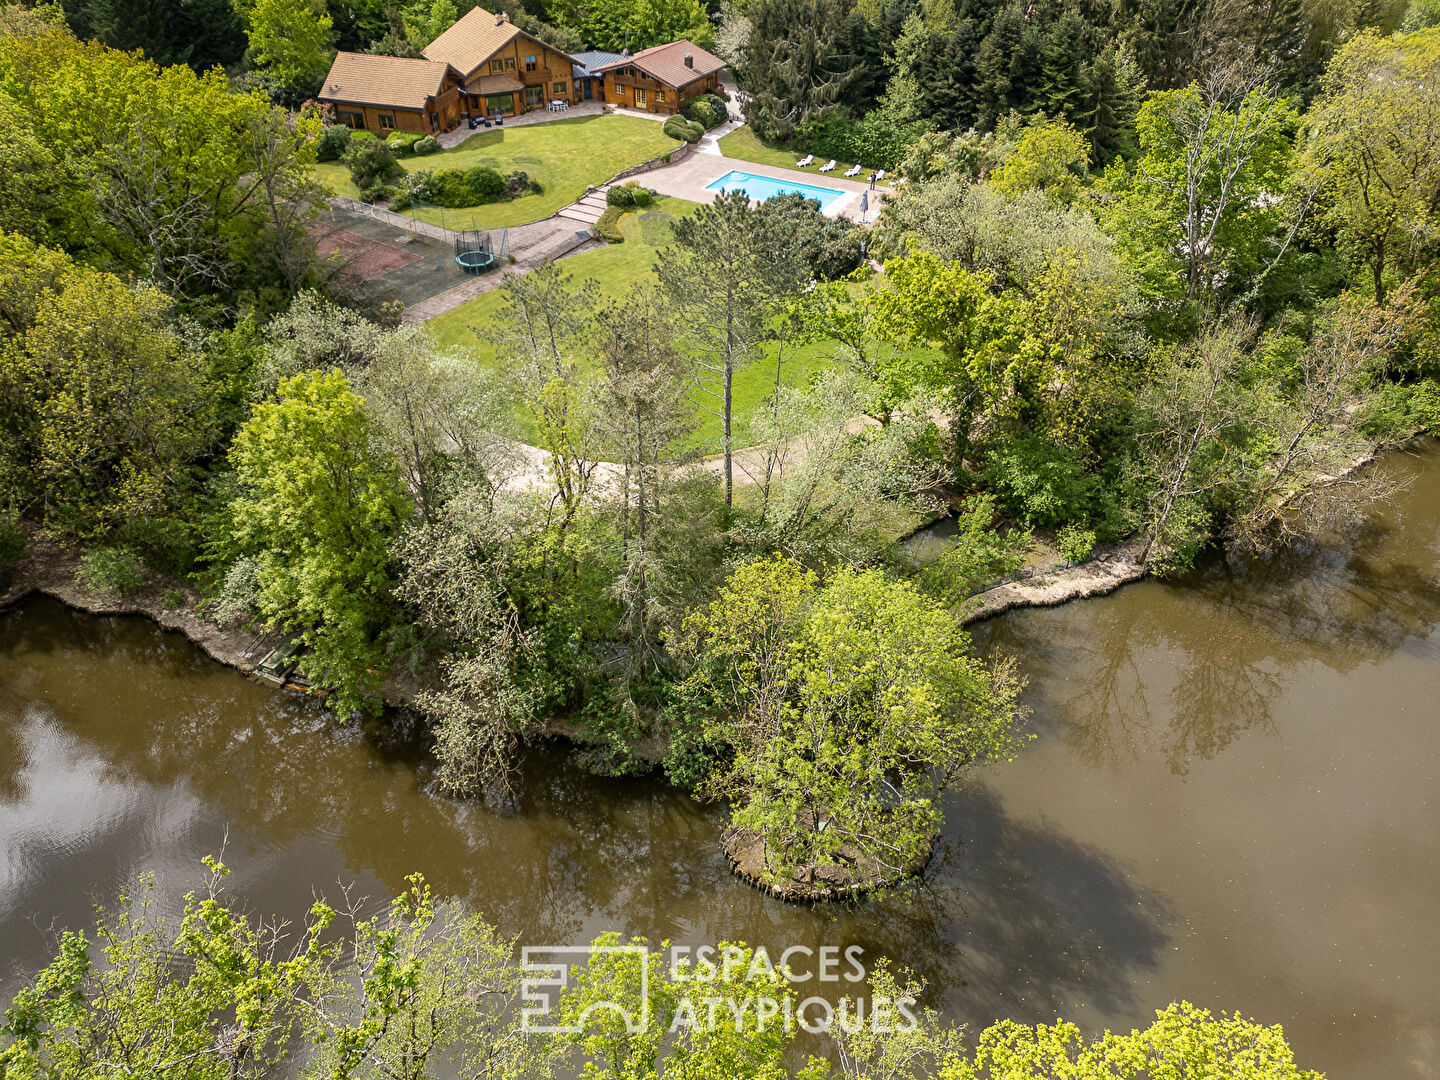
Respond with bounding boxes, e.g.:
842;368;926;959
684;557;1021;881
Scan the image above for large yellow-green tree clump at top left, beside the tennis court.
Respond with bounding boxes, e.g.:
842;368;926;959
0;30;318;302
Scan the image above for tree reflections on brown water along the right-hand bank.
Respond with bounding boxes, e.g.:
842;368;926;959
976;506;1440;775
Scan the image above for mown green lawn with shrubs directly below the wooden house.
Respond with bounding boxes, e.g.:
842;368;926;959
315;115;678;229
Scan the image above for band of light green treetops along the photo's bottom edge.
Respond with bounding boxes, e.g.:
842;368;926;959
0;857;1323;1080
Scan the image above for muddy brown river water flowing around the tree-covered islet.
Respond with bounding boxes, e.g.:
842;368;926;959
8;446;1440;1079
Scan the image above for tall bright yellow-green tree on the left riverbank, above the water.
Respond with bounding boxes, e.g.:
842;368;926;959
225;370;410;713
